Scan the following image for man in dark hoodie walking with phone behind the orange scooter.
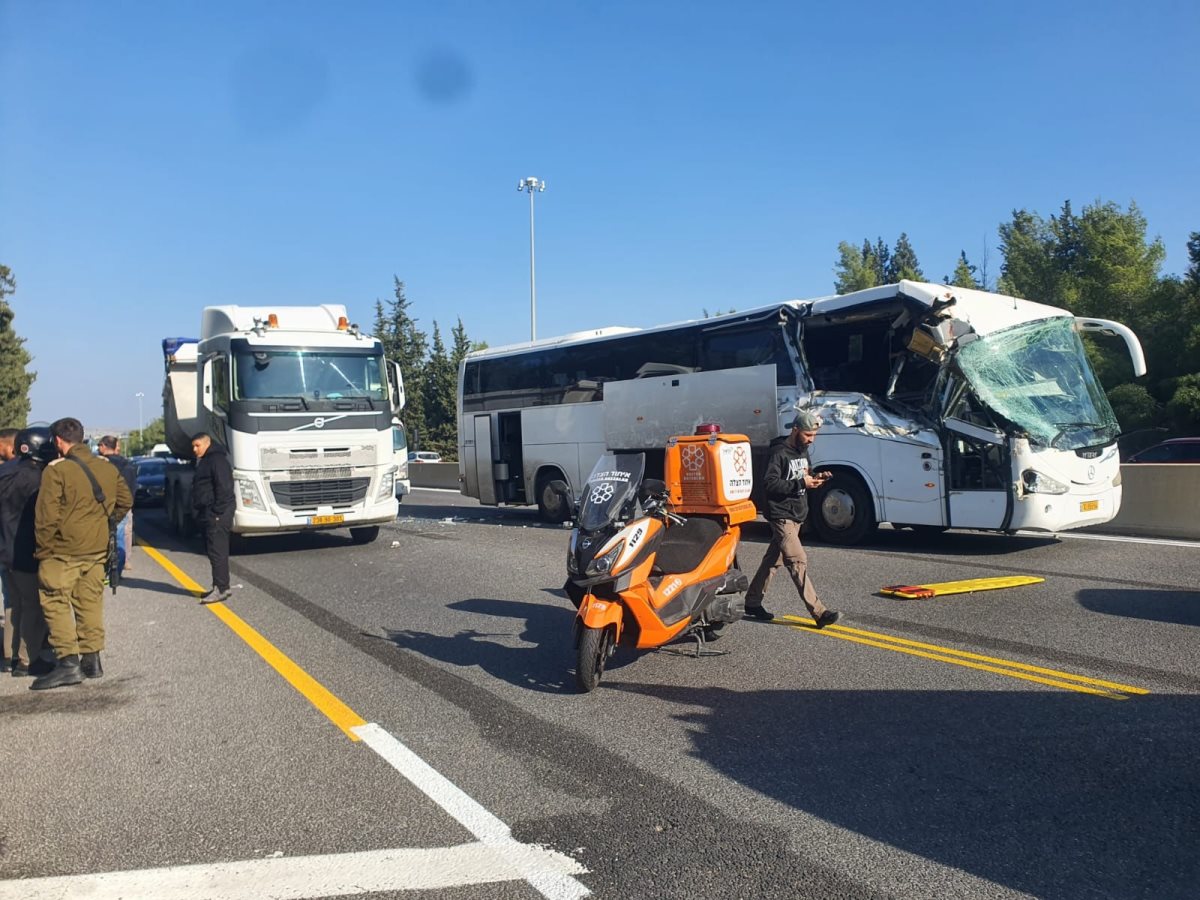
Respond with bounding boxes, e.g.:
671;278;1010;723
745;409;840;628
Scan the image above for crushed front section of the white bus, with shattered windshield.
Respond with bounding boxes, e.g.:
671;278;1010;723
798;282;1146;544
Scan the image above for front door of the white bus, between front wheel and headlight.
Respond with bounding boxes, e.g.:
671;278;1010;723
944;419;1013;529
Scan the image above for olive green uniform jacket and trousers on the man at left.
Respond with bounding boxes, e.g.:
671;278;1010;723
34;444;133;659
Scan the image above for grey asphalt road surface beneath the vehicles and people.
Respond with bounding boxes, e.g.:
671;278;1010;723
0;491;1200;900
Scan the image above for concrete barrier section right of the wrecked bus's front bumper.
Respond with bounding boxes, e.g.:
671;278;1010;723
1092;462;1200;540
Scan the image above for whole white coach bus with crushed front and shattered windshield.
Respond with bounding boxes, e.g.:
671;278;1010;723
458;281;1146;544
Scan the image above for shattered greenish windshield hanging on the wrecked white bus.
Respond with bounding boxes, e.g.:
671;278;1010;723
956;318;1121;450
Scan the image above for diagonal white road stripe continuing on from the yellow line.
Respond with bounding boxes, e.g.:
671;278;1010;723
350;722;592;900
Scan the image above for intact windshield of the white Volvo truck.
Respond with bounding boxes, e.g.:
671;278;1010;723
234;349;388;401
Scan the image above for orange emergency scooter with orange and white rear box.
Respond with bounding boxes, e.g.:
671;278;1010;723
565;425;757;691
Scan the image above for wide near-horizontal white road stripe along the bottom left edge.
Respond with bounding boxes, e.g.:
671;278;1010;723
0;844;576;900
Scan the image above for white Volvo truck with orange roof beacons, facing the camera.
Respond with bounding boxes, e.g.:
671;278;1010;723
162;305;408;544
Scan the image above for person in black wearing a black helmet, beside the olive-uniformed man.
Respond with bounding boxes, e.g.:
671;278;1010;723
0;426;59;677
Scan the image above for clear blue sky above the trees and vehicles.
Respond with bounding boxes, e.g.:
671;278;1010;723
0;0;1200;428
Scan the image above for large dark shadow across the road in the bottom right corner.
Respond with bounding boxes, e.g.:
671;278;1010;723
601;682;1200;899
